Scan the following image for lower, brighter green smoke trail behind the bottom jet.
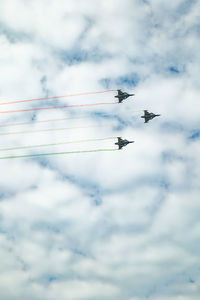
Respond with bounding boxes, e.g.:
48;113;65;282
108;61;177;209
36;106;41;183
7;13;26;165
0;149;118;159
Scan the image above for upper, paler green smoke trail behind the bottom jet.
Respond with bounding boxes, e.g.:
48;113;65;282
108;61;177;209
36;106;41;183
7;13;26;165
0;137;116;151
